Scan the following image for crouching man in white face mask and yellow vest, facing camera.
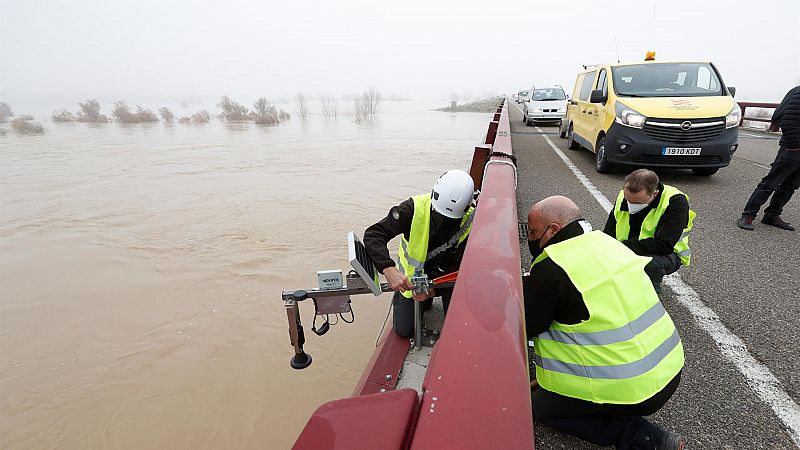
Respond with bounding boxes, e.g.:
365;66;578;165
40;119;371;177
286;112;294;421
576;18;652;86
603;169;695;293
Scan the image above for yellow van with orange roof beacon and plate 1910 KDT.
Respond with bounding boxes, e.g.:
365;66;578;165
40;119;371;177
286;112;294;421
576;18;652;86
561;61;741;176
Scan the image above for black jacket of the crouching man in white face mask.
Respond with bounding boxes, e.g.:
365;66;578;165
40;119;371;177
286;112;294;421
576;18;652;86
603;183;689;256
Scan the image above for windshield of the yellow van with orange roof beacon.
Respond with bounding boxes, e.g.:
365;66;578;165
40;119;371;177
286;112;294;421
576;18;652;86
611;63;723;97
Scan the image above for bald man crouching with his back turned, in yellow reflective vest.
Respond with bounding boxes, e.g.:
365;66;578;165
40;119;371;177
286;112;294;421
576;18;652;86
524;196;684;449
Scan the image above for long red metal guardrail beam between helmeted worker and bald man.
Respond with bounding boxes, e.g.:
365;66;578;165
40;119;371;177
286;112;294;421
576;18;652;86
411;101;534;449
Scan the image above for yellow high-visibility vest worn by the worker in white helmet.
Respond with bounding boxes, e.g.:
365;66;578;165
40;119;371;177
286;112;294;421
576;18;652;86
397;193;474;298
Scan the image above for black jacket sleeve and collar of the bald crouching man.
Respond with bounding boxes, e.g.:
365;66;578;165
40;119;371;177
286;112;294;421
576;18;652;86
523;220;589;339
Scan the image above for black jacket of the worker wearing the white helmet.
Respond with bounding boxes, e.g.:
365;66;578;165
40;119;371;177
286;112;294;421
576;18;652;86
364;198;467;277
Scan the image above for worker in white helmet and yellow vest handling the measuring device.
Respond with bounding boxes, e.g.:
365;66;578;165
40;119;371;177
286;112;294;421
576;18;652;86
364;170;474;337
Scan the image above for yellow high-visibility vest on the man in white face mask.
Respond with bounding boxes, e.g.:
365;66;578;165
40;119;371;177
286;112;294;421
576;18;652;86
614;184;696;267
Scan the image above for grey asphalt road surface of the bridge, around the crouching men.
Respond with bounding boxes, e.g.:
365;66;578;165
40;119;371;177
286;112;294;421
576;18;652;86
510;101;800;449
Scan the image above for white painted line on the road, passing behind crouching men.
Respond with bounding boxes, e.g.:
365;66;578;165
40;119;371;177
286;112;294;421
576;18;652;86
518;116;800;447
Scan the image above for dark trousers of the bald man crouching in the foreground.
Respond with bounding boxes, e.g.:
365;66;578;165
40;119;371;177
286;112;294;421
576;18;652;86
531;373;681;449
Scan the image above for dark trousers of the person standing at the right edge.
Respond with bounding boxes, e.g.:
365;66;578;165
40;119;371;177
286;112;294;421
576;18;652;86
742;147;800;217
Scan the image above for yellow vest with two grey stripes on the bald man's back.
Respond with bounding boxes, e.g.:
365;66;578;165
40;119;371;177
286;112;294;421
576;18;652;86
531;231;684;404
